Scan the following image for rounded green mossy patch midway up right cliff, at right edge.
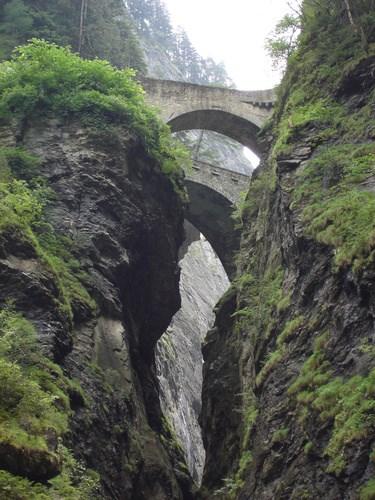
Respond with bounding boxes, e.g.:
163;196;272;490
293;144;375;271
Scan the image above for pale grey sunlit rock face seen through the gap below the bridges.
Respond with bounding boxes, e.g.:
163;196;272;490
156;223;229;484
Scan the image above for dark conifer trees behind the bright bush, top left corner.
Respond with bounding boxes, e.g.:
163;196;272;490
0;0;145;71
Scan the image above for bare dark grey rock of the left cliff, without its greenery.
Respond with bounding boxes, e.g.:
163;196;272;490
0;115;198;500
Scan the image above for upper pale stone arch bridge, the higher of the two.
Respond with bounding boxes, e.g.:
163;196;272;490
141;78;275;155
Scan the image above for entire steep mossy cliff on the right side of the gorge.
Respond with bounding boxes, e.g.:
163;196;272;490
201;2;375;500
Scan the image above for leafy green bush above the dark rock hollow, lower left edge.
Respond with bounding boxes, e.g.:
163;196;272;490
0;308;70;450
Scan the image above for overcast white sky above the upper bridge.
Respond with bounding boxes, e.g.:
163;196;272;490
164;0;294;90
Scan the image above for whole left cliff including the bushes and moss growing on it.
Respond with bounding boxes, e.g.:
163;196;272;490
0;43;197;500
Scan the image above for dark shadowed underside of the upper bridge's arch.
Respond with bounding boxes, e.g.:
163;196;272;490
167;109;262;157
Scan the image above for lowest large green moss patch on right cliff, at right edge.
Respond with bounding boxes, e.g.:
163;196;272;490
288;333;375;474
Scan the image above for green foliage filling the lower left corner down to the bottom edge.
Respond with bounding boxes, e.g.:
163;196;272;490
0;305;97;500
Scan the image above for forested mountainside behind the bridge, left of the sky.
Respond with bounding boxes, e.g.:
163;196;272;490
0;0;232;85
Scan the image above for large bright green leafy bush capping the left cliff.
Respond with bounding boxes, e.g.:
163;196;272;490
0;39;188;185
